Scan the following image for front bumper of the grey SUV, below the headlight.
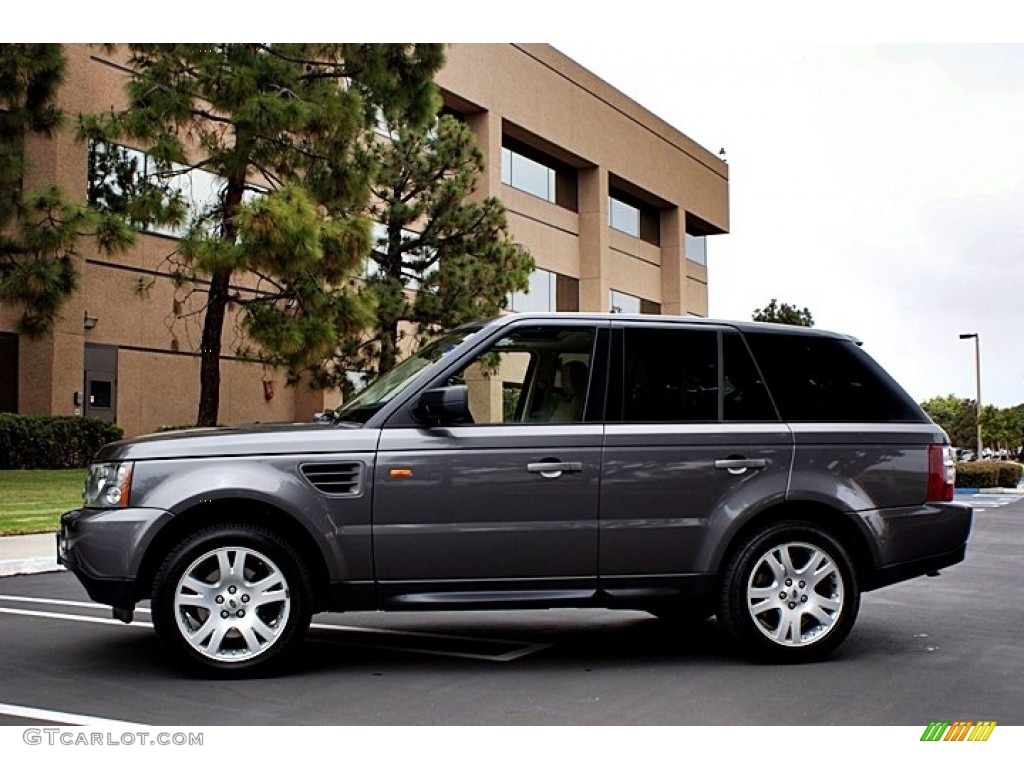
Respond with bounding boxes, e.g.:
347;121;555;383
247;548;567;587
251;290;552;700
56;508;170;608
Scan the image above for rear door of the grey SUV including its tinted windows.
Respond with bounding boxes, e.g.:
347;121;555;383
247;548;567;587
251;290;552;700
600;322;793;600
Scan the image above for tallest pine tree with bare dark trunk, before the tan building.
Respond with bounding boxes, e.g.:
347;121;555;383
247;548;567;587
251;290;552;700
82;43;443;426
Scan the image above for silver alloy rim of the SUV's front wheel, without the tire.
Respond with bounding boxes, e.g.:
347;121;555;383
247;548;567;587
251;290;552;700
174;547;292;663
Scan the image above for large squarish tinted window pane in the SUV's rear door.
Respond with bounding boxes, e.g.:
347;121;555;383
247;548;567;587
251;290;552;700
623;328;719;422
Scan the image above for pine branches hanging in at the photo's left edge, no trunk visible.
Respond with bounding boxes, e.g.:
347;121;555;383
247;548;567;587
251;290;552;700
0;43;134;338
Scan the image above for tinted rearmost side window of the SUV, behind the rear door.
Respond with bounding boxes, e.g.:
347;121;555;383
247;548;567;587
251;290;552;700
746;333;925;423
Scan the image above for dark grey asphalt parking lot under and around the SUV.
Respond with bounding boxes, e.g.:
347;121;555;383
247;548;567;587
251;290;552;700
0;497;1024;727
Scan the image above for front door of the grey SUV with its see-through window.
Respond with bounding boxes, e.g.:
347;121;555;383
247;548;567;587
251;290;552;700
374;325;603;603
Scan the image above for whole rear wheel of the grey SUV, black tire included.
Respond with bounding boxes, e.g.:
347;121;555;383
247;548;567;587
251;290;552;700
718;520;860;663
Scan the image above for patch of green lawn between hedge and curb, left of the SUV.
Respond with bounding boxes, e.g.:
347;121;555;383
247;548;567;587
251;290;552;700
0;469;85;536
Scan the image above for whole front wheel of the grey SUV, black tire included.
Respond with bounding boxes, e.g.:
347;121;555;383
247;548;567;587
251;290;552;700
153;523;311;677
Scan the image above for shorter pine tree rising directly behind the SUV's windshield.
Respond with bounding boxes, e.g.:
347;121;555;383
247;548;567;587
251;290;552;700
339;115;534;373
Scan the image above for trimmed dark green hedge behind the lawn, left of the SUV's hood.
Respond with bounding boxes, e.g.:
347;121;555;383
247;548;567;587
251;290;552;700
0;414;124;469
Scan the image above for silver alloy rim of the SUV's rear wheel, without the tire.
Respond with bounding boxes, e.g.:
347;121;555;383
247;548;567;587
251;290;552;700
746;542;844;646
